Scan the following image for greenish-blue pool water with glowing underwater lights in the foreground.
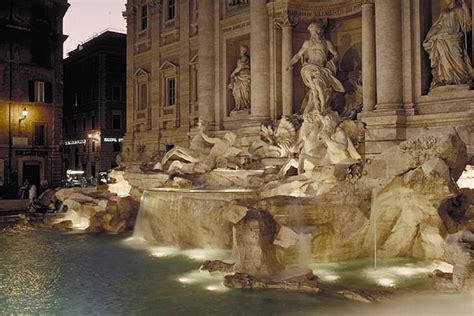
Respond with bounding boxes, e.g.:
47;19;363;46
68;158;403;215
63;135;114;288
0;229;469;315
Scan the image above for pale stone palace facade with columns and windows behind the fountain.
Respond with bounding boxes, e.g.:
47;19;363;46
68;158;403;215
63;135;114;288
122;0;474;161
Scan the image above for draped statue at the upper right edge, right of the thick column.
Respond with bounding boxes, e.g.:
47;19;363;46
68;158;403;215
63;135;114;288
423;0;474;89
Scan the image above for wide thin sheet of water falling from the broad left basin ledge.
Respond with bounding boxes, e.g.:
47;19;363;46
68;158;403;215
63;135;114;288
132;188;255;250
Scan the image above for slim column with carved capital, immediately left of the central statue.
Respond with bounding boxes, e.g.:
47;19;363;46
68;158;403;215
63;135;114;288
279;18;295;116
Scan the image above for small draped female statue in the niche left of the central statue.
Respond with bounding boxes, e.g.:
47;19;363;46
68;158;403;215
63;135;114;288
228;45;250;111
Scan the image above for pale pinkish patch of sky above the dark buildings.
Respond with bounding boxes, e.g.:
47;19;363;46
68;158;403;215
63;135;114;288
64;0;126;55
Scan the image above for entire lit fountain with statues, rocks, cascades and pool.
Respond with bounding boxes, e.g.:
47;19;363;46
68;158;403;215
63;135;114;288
0;1;474;315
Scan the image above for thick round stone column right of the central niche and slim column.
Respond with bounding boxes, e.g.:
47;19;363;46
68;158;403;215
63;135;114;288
376;0;402;111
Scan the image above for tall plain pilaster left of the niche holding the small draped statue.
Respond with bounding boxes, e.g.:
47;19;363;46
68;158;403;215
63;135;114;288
197;1;215;127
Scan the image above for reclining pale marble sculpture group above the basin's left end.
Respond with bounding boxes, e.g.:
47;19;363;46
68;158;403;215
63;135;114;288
157;120;241;173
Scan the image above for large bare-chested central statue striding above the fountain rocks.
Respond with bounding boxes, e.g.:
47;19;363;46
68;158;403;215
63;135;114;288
287;20;345;114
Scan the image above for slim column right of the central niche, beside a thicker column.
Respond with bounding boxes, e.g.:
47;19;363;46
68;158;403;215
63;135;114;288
362;0;377;112
